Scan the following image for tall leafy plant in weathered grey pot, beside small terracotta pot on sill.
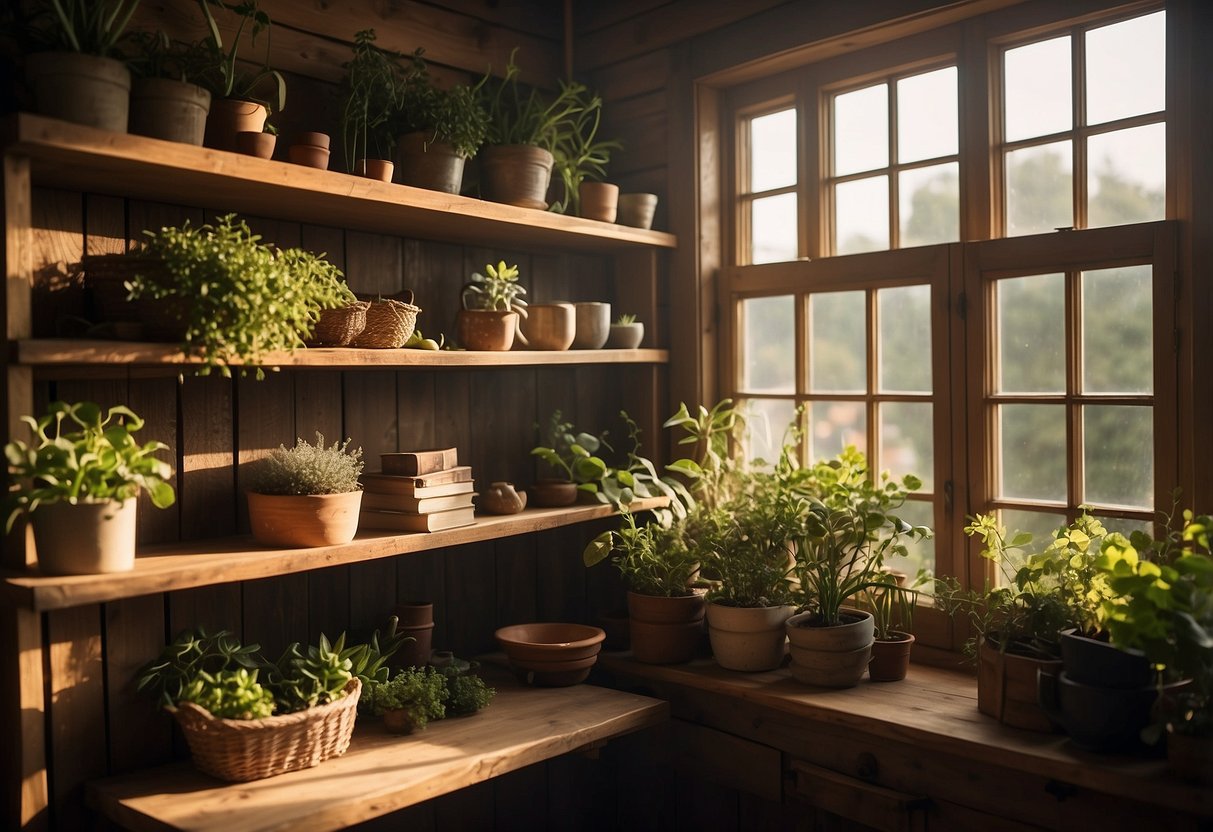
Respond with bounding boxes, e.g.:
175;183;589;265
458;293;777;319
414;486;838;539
787;448;930;688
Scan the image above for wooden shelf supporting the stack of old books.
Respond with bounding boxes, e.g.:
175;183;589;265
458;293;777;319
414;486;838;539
0;497;666;611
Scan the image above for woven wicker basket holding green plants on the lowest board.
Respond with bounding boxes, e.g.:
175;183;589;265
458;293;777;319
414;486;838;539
172;678;363;781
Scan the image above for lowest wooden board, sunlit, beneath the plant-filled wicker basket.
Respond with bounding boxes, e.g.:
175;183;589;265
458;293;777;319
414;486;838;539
89;672;670;832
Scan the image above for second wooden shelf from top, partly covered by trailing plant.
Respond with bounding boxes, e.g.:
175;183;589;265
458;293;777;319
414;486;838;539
17;338;670;370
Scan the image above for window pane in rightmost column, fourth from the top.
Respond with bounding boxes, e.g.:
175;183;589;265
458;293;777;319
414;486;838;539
1082;405;1154;508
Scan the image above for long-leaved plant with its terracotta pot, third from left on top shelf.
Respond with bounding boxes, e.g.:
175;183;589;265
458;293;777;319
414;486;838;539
198;0;286;150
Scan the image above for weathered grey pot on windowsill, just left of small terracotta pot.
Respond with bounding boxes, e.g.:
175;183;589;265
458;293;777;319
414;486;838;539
786;608;875;688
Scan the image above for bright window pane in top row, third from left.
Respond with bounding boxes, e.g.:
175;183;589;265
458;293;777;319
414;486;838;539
898;67;957;163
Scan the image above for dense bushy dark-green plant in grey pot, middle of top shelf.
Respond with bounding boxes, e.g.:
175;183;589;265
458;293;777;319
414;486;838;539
395;50;489;194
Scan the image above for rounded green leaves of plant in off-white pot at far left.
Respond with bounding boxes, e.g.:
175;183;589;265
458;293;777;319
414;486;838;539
4;401;176;531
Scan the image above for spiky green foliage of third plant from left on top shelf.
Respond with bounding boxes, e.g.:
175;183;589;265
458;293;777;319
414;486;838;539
198;0;286;112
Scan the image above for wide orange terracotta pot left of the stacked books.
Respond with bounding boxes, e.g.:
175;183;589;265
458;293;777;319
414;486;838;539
249;491;363;548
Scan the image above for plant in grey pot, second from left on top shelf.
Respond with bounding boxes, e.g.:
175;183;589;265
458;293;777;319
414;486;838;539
130;30;211;144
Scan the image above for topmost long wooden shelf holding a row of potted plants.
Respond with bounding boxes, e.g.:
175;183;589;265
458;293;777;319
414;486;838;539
2;113;677;251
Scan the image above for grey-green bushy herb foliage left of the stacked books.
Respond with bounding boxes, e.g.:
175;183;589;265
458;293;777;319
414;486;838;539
249;432;363;496
